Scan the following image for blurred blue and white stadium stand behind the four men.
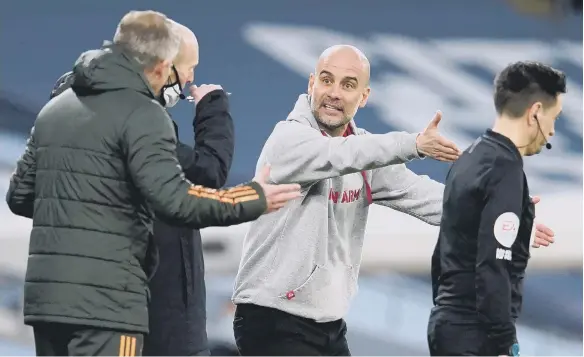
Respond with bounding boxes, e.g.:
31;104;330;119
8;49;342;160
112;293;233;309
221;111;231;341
0;0;583;356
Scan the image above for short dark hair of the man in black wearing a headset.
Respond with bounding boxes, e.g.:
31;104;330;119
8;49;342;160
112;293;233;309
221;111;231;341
494;62;566;118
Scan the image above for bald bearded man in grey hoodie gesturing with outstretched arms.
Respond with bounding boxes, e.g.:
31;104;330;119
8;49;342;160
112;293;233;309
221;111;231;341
233;45;460;356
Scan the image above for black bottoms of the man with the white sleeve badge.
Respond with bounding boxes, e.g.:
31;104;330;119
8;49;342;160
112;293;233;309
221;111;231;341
428;307;497;356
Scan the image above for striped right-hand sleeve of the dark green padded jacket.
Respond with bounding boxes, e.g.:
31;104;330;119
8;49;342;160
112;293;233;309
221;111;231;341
122;104;267;228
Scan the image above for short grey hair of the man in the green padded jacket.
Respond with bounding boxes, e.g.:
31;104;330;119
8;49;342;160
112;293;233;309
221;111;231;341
114;10;181;69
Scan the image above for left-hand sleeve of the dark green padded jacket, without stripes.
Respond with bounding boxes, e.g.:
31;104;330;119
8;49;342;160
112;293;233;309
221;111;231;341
6;127;36;218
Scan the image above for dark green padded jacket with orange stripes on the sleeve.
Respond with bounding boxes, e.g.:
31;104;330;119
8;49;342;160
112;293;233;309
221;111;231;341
6;46;266;333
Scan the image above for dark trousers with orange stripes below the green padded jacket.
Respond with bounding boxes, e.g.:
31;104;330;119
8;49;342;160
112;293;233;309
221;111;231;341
32;323;144;357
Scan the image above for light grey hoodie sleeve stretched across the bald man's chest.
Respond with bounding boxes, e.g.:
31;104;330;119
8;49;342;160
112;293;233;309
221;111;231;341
259;120;420;185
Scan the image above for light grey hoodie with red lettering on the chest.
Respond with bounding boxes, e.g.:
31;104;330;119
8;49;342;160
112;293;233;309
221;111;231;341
233;94;444;322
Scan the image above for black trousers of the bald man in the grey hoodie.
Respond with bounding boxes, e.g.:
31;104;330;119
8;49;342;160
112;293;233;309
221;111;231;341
233;304;351;356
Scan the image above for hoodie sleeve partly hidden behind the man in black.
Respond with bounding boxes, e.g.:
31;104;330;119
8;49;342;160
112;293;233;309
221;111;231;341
371;164;444;226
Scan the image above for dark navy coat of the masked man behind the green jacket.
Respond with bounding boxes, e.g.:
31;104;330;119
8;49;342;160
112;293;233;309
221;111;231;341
143;90;235;356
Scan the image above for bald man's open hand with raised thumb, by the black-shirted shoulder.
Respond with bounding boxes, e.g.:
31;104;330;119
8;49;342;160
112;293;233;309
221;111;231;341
416;111;462;162
